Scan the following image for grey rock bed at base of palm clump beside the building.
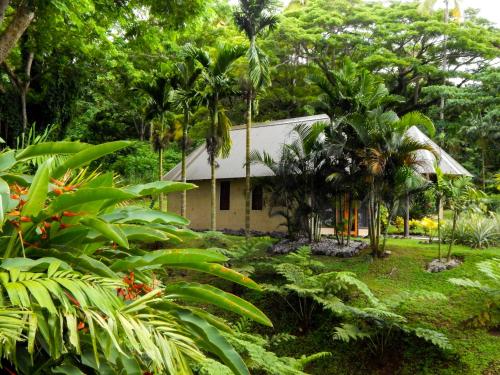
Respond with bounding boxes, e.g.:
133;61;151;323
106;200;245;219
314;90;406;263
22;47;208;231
271;237;368;258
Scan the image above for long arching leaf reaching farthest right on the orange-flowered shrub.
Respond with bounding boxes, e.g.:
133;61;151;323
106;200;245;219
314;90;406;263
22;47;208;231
165;282;273;327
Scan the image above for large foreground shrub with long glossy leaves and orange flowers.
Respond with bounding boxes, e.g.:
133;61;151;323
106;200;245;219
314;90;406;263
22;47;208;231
0;142;271;374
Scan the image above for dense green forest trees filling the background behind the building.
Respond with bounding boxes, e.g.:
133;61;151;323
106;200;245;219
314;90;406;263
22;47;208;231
0;0;499;190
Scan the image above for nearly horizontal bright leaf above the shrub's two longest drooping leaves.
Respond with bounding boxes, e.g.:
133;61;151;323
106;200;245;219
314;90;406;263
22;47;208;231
111;249;228;271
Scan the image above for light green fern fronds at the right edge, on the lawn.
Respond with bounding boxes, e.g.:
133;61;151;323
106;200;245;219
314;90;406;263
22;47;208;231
449;258;500;327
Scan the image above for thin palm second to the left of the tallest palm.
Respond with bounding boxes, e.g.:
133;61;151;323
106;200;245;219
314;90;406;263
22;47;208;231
174;44;205;216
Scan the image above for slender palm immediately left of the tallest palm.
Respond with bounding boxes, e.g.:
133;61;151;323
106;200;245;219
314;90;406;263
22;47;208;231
198;46;245;230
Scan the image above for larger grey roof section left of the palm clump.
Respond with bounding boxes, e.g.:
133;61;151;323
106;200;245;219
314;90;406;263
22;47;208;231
164;115;330;181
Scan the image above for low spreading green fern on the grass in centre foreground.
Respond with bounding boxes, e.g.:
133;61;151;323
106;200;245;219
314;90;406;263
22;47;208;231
265;247;450;354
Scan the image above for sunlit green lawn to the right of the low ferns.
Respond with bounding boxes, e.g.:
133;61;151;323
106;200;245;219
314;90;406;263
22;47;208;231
308;239;500;374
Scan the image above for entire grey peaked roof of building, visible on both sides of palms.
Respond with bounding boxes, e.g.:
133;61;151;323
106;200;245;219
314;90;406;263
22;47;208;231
164;114;471;181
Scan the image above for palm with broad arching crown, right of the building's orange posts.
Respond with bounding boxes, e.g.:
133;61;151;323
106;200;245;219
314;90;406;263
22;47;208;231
349;108;434;257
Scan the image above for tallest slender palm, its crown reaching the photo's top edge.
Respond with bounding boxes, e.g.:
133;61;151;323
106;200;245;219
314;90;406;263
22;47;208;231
234;0;278;237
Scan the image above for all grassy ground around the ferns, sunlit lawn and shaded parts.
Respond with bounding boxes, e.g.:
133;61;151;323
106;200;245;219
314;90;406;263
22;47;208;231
167;234;500;375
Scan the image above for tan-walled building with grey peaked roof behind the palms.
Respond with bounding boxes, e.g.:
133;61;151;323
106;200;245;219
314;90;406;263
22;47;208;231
164;114;471;234
